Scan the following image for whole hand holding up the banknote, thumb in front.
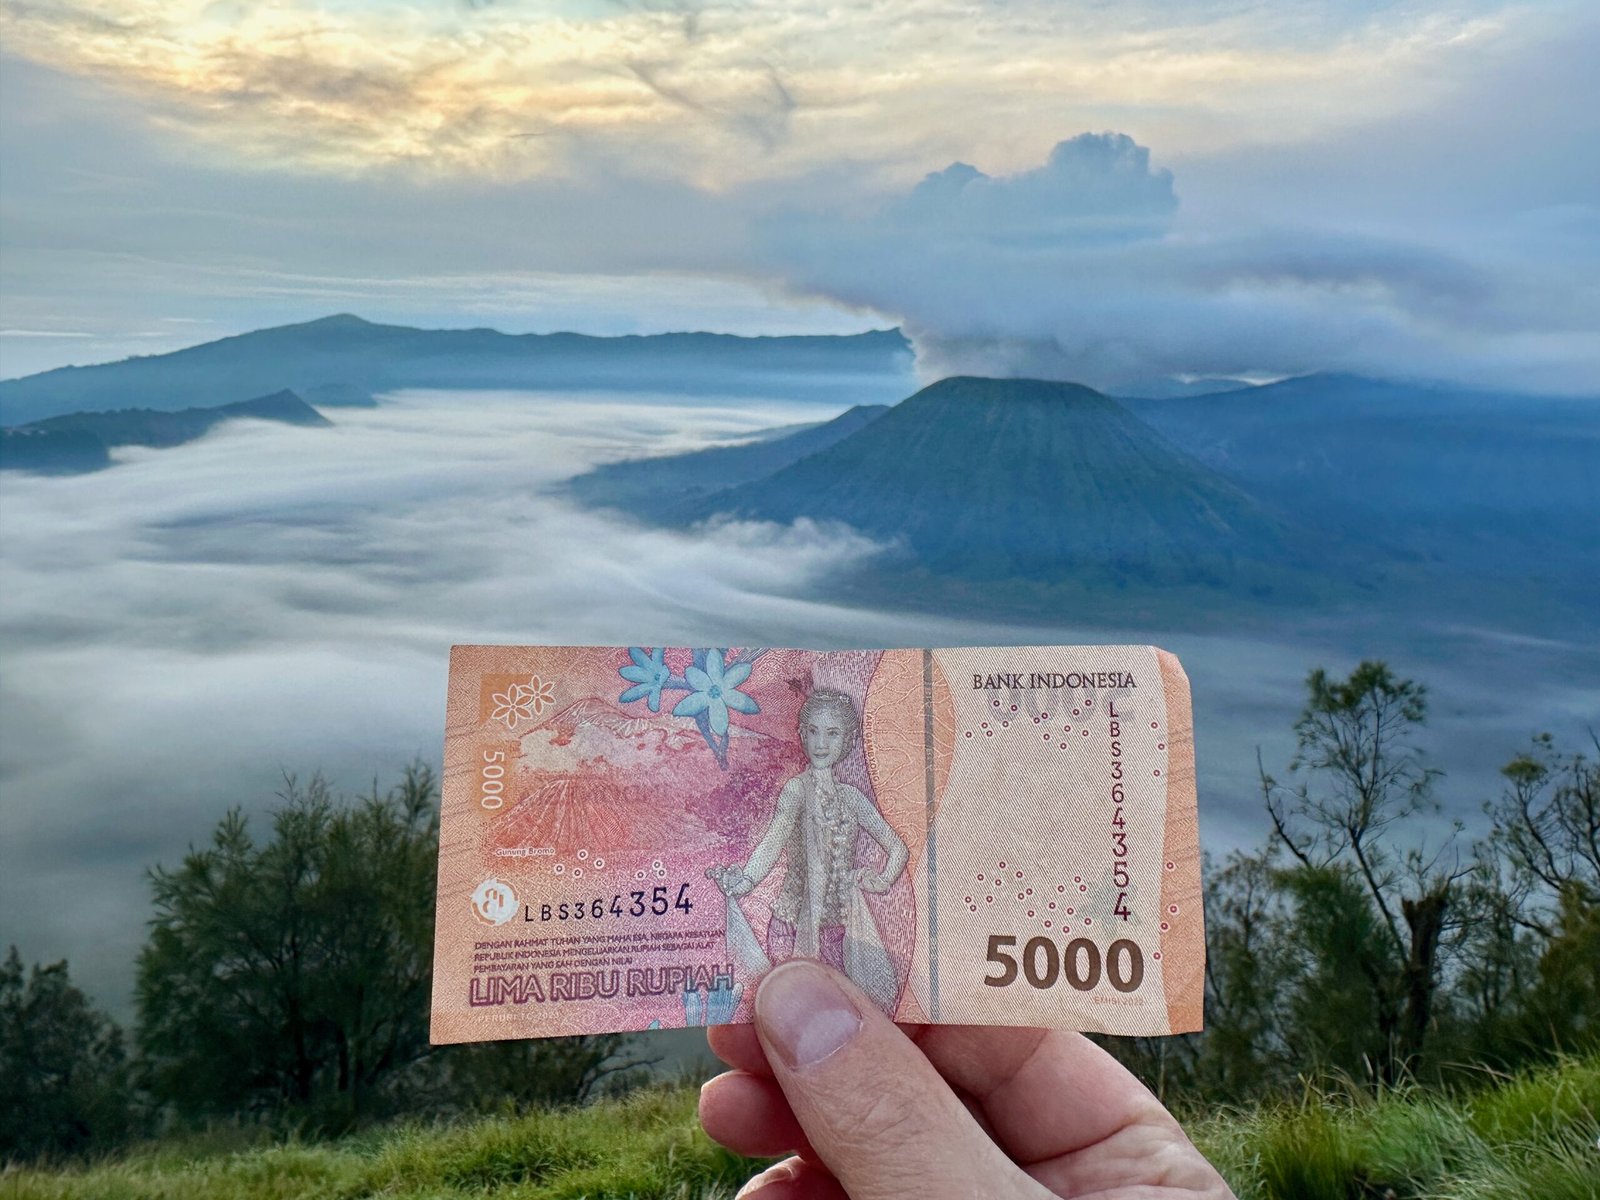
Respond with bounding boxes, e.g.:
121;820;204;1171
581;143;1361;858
699;960;1234;1200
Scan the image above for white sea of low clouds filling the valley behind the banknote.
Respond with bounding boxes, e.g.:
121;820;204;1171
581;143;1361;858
0;392;1600;1014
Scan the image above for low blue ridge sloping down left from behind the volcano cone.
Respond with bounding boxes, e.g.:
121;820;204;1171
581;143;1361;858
568;405;890;522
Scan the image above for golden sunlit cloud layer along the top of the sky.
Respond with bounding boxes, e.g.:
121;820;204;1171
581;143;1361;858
0;0;1539;187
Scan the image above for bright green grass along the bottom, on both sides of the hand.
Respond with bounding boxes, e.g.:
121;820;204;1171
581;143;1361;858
0;1056;1600;1200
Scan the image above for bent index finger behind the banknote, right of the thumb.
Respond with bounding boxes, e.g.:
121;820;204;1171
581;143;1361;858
917;1026;1178;1163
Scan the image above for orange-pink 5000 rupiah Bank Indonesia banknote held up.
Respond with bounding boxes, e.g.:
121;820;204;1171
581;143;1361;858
432;646;1205;1043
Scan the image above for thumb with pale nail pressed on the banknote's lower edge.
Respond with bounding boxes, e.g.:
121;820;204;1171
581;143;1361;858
755;960;1048;1200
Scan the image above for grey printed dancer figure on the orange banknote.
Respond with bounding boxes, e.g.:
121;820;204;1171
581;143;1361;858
706;688;907;1010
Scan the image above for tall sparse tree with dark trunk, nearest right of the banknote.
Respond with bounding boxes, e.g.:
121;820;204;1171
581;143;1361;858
1261;661;1467;1082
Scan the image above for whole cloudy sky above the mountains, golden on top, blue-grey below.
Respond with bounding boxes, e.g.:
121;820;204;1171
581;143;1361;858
0;0;1600;394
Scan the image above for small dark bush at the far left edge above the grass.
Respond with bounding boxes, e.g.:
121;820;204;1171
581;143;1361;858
0;946;133;1162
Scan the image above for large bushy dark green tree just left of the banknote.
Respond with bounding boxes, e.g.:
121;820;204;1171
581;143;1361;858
138;766;438;1126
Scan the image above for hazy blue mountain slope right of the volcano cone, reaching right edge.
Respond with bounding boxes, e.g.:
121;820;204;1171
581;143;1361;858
1125;374;1600;581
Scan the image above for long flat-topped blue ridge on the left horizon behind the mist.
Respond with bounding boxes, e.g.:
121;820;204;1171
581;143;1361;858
0;314;910;426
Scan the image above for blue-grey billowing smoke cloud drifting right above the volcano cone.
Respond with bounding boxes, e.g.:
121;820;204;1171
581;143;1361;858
760;134;1600;394
